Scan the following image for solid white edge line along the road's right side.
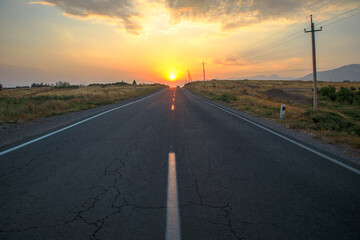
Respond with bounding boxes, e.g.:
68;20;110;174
185;89;360;175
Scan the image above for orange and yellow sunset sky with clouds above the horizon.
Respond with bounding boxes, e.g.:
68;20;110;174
0;0;360;87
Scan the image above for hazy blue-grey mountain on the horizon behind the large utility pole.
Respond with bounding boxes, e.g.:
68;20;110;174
299;64;360;82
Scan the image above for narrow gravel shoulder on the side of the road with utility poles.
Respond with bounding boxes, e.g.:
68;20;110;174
187;89;360;168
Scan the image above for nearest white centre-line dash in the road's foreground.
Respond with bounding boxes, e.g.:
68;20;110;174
165;152;181;240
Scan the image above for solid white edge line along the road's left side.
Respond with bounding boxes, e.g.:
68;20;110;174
0;89;164;156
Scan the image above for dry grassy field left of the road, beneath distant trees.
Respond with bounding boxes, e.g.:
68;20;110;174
0;84;164;123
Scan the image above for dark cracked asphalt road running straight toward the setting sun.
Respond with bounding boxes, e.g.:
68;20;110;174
0;88;360;240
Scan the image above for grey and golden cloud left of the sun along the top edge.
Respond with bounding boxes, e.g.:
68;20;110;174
29;0;142;35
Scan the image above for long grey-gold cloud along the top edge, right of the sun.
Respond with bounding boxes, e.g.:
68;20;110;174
165;0;358;30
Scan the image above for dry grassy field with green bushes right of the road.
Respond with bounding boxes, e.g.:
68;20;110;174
185;80;360;149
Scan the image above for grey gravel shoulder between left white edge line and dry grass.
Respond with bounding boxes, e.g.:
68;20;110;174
0;89;162;151
